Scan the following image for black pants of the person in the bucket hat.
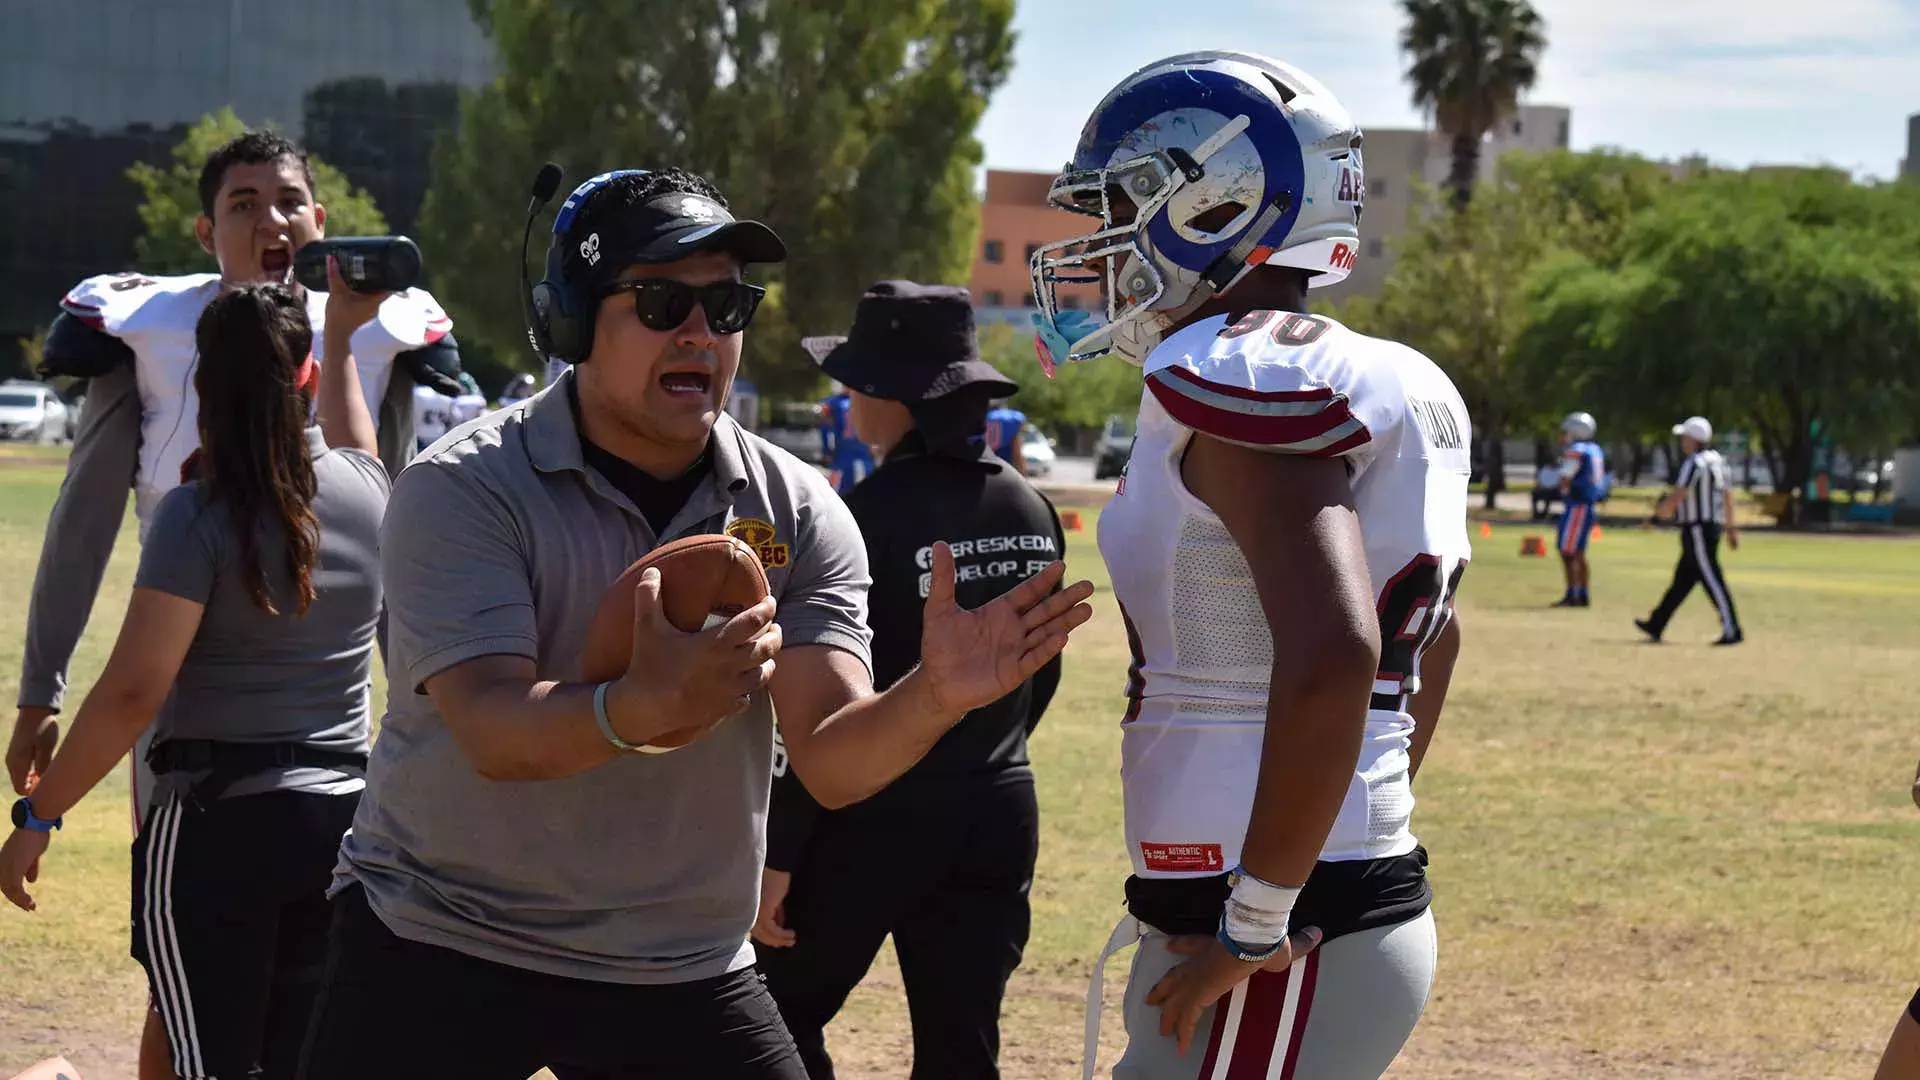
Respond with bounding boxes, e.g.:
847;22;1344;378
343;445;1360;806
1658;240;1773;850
755;771;1041;1080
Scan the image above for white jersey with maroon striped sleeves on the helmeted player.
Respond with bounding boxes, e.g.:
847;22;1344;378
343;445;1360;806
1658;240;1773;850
1100;311;1473;878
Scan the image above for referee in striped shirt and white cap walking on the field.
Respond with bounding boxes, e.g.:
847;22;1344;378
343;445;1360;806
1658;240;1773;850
1634;417;1745;646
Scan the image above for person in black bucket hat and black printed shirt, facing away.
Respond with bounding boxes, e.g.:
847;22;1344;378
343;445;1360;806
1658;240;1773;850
753;281;1066;1080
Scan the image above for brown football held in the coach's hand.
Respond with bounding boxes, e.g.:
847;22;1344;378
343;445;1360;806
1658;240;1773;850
580;532;768;749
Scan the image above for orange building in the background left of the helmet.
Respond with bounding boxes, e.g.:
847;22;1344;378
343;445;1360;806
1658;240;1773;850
968;169;1100;325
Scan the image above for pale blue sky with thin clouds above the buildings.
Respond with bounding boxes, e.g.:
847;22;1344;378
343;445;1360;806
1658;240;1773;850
979;0;1920;177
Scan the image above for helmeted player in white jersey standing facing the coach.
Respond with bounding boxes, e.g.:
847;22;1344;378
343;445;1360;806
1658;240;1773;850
1031;52;1471;1080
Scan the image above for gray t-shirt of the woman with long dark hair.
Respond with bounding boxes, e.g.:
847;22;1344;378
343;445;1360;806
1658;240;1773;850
134;427;388;798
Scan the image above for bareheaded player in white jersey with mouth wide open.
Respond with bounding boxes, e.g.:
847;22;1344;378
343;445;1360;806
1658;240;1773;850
6;133;459;1074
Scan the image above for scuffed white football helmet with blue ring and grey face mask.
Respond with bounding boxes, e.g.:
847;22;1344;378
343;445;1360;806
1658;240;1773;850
1031;52;1367;375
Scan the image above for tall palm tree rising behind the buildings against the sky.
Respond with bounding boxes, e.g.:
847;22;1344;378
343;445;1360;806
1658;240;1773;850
1400;0;1548;208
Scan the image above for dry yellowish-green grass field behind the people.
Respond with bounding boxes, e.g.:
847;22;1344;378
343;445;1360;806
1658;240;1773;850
0;454;1920;1080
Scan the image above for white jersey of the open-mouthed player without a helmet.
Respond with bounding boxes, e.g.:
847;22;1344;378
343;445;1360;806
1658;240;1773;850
60;273;453;540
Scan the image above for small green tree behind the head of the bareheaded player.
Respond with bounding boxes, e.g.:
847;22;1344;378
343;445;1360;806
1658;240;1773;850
127;108;386;275
